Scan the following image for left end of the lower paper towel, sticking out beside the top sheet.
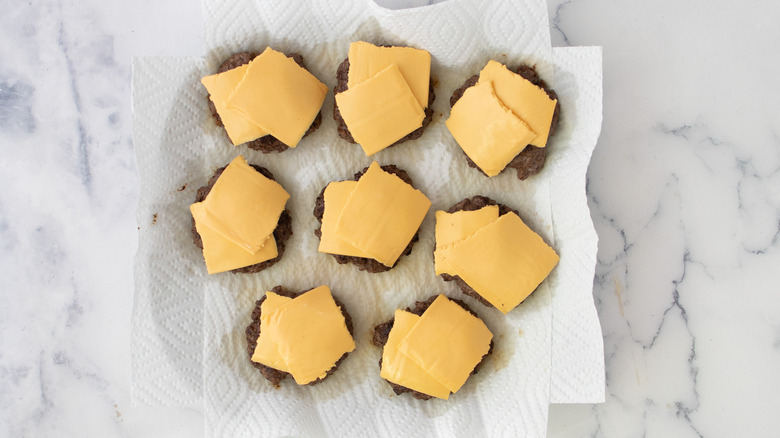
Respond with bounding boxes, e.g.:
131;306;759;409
131;58;207;407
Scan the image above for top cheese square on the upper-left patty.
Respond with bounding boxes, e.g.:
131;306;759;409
227;47;328;148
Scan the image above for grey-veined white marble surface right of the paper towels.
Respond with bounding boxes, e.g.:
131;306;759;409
549;0;780;437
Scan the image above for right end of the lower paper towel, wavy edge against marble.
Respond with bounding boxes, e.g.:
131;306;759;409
547;47;605;403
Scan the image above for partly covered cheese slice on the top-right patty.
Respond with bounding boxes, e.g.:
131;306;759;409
479;61;557;147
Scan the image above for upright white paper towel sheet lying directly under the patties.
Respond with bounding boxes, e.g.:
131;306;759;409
198;0;554;436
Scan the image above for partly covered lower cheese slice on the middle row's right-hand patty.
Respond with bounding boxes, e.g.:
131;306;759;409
433;205;498;275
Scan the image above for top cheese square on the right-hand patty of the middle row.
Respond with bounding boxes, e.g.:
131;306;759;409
441;213;558;313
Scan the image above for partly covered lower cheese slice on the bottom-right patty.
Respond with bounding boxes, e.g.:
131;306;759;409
379;309;450;400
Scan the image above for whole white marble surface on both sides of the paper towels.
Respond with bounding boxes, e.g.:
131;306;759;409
0;0;780;437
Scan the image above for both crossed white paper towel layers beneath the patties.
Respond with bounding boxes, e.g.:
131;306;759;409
133;0;603;436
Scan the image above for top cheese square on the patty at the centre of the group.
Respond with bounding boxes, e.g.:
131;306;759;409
335;161;431;266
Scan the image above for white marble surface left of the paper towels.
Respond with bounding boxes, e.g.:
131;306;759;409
0;2;199;436
